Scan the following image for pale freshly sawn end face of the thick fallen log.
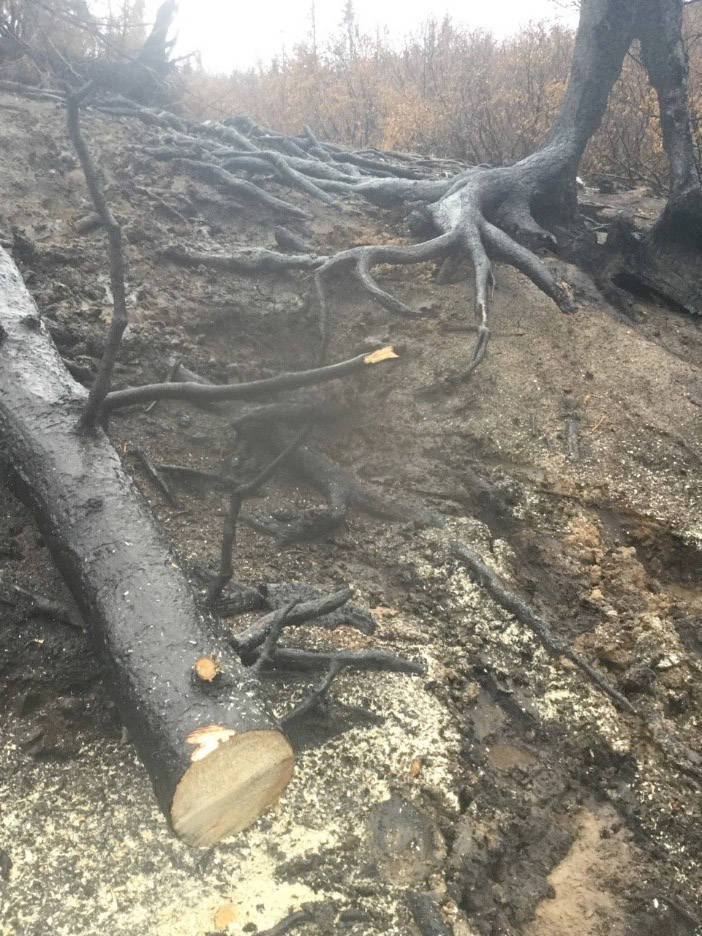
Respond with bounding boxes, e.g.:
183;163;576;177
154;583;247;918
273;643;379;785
171;725;294;848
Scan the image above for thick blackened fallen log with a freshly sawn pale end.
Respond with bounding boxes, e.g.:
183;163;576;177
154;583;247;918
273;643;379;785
0;248;293;846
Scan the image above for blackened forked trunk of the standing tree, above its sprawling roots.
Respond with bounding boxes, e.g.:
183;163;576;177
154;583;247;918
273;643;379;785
532;0;702;314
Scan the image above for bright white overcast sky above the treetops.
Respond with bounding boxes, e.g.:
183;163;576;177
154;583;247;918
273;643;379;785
147;0;573;72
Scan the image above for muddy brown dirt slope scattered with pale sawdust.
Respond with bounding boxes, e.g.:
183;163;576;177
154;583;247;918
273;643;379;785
0;95;702;936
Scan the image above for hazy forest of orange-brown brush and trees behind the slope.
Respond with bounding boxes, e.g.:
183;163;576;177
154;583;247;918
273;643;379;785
0;0;702;193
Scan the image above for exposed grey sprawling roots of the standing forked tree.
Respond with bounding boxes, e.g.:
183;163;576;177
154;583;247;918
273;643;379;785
104;92;574;378
